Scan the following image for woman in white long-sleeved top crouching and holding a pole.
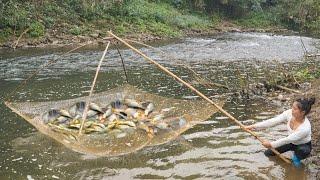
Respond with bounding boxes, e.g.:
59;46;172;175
246;98;315;167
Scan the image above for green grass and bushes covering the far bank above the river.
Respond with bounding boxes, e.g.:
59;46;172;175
0;0;320;41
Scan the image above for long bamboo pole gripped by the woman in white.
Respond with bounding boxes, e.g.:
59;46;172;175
108;31;291;163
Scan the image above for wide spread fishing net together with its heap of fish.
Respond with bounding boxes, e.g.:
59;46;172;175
6;85;224;156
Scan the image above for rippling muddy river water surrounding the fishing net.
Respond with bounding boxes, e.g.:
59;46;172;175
0;33;320;179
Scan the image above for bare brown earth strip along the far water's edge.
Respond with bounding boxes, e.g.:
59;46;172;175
0;21;296;49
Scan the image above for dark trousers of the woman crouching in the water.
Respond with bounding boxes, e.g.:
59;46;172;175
264;142;311;160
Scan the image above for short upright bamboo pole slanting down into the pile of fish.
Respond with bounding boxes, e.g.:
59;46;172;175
79;41;110;135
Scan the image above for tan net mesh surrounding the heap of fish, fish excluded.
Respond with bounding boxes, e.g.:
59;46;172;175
6;85;223;156
